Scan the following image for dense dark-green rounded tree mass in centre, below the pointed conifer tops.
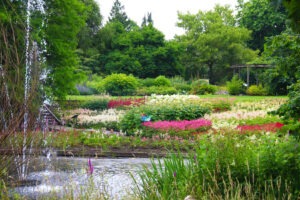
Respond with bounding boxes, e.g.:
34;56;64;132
98;18;183;78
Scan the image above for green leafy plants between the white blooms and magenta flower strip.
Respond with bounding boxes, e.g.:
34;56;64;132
120;103;211;135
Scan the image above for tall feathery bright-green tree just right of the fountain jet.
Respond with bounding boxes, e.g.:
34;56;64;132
45;0;84;98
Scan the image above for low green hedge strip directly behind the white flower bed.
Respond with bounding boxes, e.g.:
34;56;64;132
136;86;178;96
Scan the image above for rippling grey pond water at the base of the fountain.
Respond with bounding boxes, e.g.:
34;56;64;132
14;157;151;199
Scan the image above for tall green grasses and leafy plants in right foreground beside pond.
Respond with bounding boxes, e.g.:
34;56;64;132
137;134;300;199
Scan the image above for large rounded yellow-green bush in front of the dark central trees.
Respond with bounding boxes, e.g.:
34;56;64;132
103;74;138;96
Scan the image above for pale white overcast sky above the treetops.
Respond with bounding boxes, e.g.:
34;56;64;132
95;0;237;40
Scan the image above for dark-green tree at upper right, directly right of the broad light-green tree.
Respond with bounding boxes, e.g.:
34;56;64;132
238;0;286;52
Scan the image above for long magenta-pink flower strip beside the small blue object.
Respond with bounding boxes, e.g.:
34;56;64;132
143;119;211;131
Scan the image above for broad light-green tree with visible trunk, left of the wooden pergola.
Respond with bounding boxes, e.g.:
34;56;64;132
177;5;257;84
